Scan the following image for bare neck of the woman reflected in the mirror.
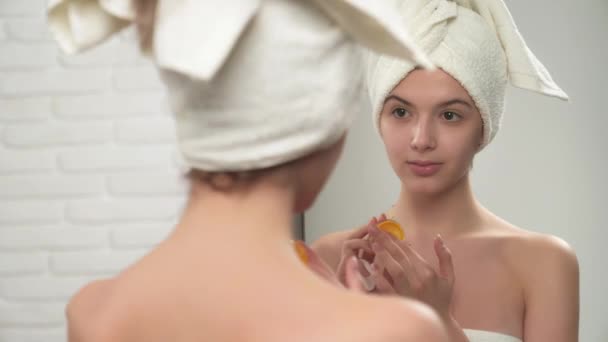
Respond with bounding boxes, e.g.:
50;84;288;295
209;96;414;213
389;175;486;238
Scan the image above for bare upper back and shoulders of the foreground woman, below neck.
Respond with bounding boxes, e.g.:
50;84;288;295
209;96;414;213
68;238;445;342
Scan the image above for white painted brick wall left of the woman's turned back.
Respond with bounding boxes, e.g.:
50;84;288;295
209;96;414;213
0;4;187;342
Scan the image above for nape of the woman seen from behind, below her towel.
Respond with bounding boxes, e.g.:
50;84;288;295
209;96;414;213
171;179;295;255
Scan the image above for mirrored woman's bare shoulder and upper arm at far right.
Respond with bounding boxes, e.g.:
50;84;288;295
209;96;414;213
490;223;579;341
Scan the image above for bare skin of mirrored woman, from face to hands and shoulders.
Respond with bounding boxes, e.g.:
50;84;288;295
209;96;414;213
312;69;579;342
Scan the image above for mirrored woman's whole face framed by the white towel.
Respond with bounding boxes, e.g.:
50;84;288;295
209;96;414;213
380;69;483;194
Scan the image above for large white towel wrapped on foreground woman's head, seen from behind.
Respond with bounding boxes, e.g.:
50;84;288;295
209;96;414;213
49;0;430;172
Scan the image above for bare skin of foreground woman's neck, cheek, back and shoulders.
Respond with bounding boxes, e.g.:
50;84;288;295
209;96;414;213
67;140;447;342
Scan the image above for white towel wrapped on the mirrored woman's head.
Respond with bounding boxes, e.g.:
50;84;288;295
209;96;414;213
367;0;568;148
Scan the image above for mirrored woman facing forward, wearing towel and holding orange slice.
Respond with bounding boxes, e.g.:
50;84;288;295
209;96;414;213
313;0;579;342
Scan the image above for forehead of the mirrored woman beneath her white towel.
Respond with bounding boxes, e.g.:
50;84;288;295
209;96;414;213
391;69;474;104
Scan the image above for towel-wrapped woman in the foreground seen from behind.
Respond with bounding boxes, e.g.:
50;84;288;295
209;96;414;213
49;0;445;342
